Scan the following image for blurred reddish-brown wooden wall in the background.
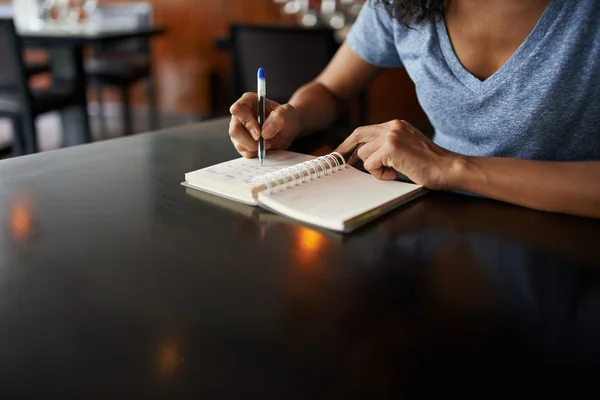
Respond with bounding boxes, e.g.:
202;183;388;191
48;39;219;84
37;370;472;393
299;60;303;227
8;0;427;129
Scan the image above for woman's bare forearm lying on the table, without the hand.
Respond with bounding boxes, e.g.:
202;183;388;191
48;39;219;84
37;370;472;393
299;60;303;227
450;157;600;218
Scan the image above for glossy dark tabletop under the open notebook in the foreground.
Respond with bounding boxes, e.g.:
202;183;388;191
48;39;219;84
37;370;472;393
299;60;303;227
0;120;600;399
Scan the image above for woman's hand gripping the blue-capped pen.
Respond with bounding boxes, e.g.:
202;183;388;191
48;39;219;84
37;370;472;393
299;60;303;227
229;93;299;158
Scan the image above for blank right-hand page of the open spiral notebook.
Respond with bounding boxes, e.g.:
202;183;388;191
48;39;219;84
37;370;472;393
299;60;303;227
258;167;422;230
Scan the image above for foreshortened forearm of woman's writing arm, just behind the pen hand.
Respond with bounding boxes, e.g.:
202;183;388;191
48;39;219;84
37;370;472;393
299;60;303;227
289;81;343;137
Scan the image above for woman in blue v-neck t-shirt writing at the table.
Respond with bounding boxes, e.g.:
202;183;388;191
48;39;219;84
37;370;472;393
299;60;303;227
229;0;600;218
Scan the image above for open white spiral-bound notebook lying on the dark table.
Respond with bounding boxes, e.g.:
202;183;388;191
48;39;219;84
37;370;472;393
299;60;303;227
183;151;425;233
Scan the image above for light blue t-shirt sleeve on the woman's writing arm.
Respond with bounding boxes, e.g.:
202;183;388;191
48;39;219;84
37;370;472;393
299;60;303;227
346;1;402;68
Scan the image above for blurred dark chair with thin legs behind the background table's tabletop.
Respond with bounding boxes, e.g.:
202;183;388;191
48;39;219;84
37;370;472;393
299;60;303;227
85;2;159;135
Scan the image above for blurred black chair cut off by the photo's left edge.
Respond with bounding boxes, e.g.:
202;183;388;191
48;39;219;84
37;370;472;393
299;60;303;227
0;19;78;155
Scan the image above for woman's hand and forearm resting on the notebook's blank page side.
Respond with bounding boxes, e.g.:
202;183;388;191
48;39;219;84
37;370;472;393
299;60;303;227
337;121;600;218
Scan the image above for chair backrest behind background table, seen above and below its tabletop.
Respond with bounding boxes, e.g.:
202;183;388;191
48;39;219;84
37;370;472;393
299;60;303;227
93;2;154;56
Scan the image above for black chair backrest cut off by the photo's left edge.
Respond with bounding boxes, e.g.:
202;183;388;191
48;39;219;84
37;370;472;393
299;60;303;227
0;18;29;95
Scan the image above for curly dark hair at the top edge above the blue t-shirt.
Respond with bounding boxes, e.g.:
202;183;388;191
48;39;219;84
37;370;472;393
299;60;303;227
370;0;444;27
